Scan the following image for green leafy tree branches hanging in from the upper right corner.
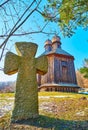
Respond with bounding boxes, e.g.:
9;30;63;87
43;0;88;37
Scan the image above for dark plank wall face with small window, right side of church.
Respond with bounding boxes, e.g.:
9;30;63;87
54;56;76;83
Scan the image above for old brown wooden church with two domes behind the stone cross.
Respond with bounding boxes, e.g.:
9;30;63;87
37;36;80;92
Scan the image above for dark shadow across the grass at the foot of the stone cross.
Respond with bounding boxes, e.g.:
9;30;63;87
11;115;88;130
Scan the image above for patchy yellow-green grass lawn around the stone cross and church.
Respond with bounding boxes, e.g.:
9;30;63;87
0;92;88;130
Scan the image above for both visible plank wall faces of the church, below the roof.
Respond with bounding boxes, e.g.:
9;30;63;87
38;55;77;85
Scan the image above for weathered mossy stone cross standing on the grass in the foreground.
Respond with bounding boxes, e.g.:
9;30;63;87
4;42;48;122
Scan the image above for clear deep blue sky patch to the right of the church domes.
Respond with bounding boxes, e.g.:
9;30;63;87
62;28;88;70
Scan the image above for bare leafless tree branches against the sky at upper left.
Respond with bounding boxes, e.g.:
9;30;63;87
0;0;54;70
